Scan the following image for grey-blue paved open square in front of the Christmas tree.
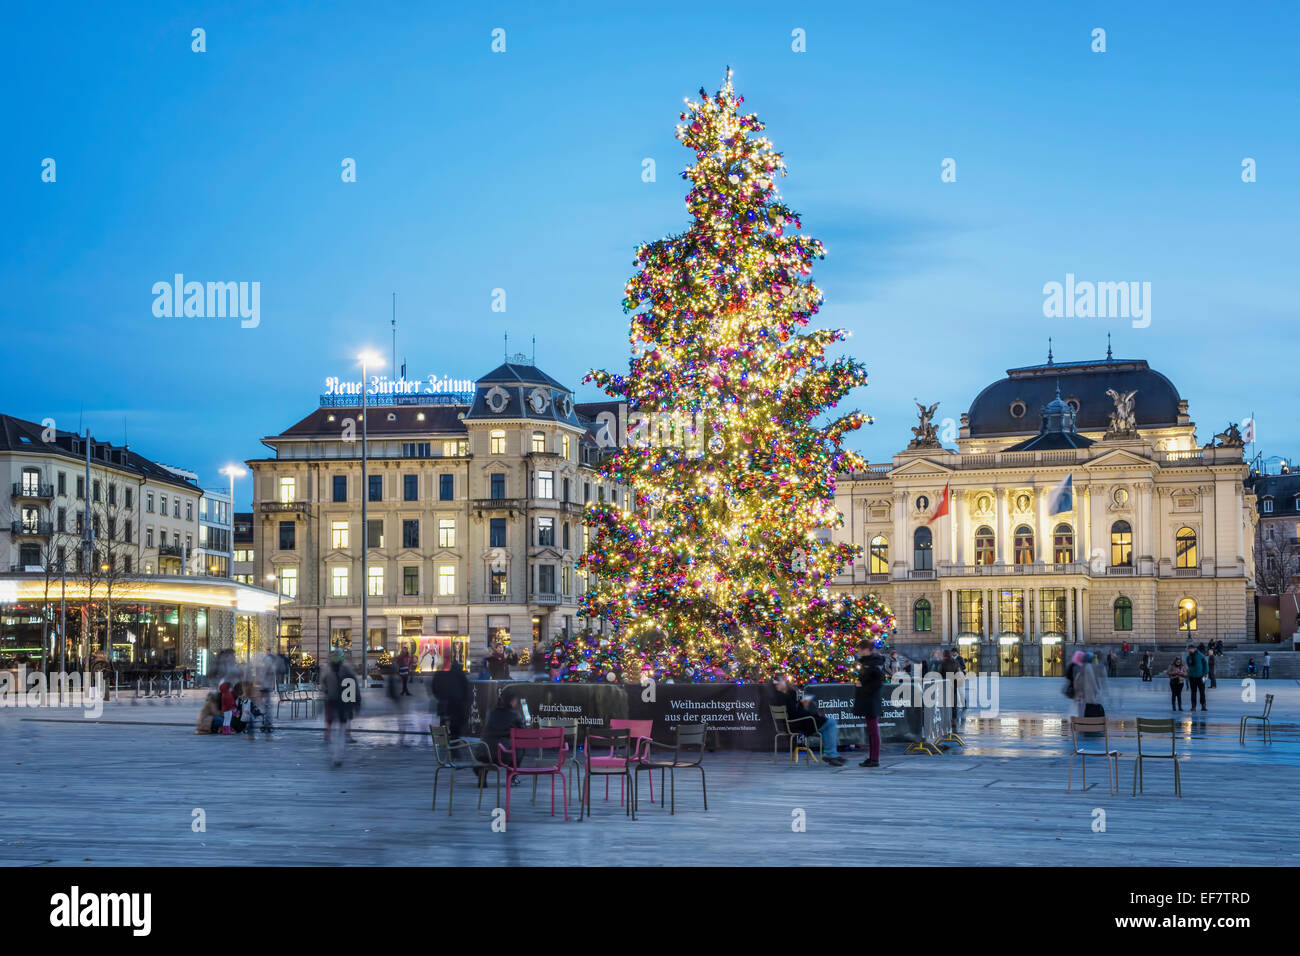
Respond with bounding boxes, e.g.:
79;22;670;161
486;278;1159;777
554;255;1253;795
0;678;1300;866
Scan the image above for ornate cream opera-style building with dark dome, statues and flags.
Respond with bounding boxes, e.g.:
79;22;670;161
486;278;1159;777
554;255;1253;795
836;351;1255;675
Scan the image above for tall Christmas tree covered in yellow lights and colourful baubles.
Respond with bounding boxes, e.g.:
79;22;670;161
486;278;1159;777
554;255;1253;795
581;70;894;680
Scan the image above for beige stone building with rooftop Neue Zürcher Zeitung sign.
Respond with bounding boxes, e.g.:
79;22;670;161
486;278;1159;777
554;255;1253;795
248;356;625;659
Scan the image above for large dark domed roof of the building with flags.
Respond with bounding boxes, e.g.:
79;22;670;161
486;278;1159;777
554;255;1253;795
967;356;1182;438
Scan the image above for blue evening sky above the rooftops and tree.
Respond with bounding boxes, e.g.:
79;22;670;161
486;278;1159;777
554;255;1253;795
0;0;1300;506
